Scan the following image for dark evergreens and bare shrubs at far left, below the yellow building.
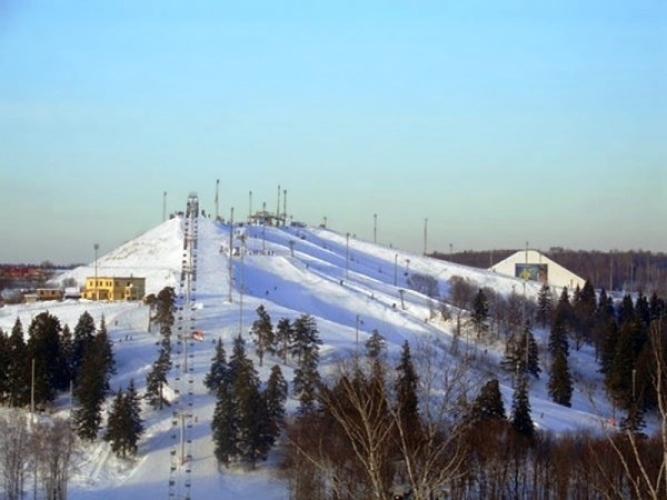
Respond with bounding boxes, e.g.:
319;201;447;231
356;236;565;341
0;311;143;500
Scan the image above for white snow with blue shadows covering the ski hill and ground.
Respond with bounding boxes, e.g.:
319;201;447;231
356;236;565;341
0;217;611;500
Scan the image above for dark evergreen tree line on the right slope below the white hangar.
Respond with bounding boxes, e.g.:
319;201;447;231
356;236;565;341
444;277;667;431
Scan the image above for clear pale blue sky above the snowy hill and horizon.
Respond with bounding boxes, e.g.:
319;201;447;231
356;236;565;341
0;0;667;263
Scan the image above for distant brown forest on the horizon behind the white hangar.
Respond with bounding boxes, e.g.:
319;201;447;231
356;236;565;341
431;247;667;293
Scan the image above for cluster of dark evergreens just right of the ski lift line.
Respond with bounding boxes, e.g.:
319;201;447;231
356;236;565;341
204;305;321;467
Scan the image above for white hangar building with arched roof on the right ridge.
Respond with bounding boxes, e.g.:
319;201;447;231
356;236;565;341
489;250;586;290
